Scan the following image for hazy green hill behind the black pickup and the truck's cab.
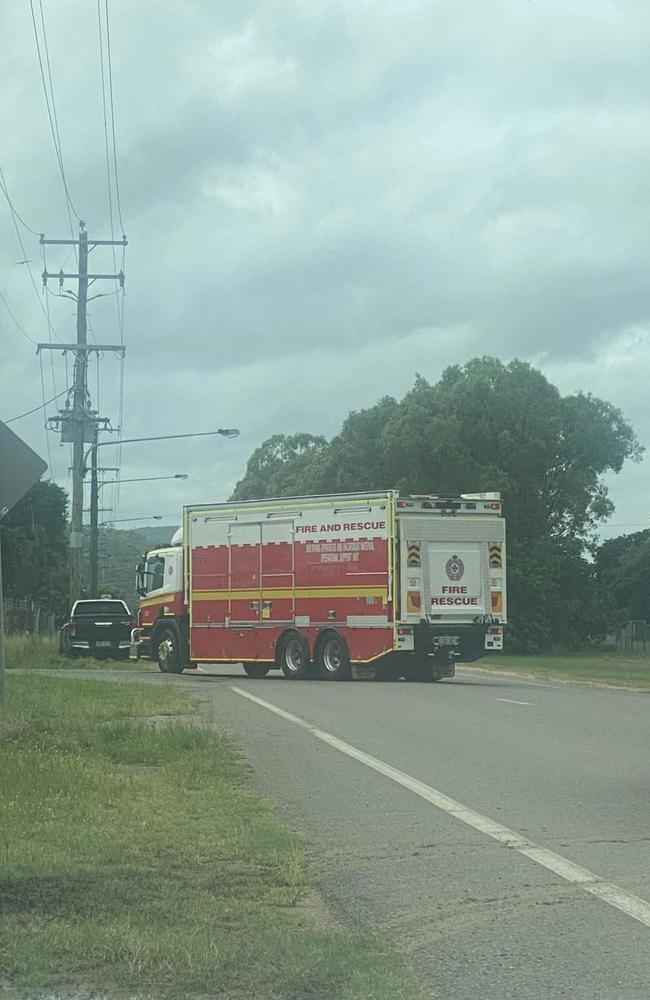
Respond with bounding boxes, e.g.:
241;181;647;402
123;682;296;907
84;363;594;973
82;524;178;611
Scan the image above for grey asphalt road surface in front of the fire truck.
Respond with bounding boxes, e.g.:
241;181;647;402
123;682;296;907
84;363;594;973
73;667;650;1000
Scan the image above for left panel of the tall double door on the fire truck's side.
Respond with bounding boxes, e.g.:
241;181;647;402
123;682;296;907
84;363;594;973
228;521;262;625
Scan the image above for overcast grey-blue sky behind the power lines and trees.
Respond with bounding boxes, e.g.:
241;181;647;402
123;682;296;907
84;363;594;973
0;0;650;535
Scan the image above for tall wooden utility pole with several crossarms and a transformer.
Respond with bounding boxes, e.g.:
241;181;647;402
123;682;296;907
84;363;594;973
37;221;126;605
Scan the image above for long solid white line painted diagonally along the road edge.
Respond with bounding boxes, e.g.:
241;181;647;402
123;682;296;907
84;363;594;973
231;686;650;927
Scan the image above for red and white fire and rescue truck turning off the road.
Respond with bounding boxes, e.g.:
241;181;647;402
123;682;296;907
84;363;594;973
131;490;506;680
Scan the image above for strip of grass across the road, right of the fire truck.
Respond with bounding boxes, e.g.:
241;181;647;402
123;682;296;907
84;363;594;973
479;649;650;690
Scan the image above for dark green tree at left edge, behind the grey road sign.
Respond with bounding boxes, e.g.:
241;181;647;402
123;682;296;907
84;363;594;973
0;482;68;614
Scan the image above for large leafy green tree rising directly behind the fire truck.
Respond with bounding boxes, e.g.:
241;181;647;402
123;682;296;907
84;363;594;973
229;357;642;649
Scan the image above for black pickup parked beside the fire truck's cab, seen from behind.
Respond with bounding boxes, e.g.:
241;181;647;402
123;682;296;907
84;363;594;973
59;598;134;659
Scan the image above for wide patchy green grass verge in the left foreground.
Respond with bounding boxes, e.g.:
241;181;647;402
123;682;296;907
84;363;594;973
0;673;424;1000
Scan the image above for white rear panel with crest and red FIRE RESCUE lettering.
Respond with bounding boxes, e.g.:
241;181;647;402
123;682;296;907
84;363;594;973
429;542;485;615
